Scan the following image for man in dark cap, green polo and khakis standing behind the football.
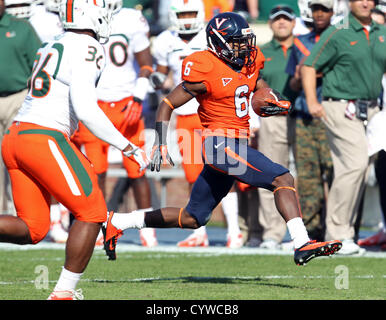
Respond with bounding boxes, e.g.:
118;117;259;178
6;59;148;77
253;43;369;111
258;6;296;249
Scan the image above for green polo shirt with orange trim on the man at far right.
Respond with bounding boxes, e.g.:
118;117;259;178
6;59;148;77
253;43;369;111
304;14;386;100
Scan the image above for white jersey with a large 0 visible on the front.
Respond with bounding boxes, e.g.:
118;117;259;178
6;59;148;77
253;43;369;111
97;8;150;101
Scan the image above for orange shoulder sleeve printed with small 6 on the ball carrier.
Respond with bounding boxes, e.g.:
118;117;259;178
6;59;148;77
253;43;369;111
182;51;213;92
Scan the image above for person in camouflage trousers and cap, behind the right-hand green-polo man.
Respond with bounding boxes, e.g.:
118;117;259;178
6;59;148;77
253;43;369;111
286;0;334;241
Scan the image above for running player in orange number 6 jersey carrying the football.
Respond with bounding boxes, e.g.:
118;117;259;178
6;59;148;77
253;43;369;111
105;12;342;265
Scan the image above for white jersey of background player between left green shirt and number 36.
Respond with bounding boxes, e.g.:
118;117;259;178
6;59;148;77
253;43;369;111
29;5;64;42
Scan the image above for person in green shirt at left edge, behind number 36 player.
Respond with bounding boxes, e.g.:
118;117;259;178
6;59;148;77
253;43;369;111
0;0;41;215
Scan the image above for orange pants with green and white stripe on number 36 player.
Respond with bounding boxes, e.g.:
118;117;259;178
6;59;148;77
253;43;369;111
2;122;107;243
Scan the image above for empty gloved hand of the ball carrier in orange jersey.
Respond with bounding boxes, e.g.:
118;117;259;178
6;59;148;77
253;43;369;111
150;122;174;172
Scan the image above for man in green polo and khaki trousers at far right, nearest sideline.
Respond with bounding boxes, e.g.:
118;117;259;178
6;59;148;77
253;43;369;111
301;0;386;254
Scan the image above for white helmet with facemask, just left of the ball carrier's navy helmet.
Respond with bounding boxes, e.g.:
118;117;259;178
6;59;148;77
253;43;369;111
169;0;205;34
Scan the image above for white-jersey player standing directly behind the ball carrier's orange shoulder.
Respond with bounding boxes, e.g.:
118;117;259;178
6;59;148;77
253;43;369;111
150;0;243;248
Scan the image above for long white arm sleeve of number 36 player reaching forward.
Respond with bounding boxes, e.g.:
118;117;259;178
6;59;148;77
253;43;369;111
70;44;129;150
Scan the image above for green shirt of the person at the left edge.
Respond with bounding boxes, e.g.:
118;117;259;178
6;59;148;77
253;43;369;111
0;13;41;93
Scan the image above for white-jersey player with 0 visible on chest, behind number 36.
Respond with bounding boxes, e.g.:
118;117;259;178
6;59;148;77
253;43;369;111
73;0;158;250
